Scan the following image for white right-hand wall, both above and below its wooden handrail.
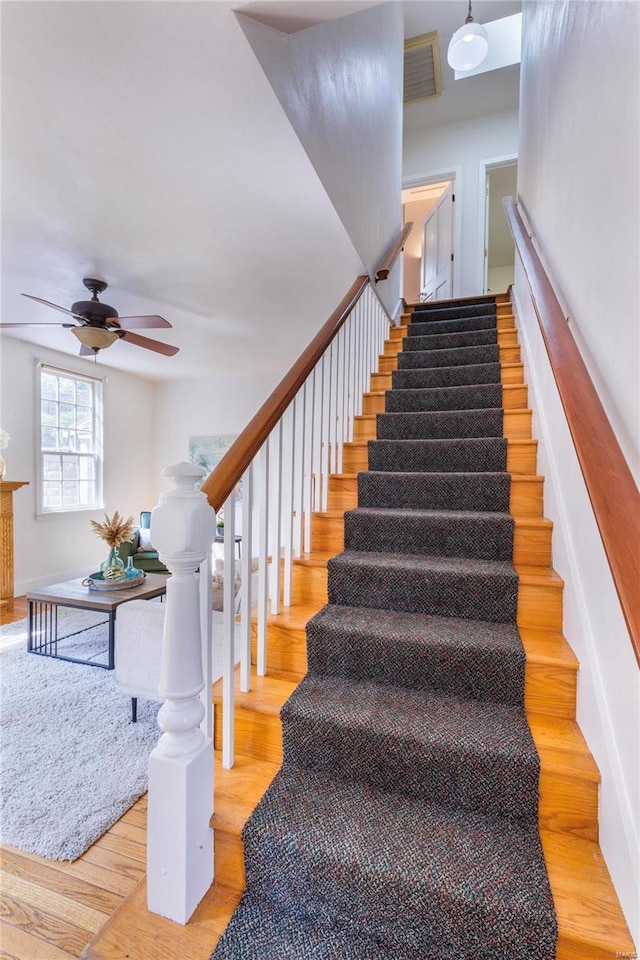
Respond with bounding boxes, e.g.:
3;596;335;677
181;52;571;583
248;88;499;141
515;0;640;943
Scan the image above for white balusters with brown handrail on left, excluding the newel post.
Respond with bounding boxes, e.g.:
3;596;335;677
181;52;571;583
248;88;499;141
201;224;412;768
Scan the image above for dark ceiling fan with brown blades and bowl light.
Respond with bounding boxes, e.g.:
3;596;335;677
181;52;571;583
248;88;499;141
0;277;179;357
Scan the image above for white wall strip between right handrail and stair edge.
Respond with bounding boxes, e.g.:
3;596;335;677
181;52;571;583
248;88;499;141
514;258;640;943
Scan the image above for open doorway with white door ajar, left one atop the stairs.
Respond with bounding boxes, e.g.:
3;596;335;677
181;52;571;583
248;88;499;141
402;178;454;303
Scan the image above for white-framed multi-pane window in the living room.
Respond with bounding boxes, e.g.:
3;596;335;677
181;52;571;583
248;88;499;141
38;365;102;513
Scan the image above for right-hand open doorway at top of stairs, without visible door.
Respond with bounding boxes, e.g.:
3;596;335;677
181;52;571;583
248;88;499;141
482;157;518;293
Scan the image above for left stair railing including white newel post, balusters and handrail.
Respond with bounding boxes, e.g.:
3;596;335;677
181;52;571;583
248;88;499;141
147;223;412;923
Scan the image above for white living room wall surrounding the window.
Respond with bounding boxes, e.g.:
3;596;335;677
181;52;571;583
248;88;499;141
0;337;157;596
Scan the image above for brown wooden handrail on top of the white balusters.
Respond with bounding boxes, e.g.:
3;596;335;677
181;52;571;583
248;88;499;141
201;276;369;512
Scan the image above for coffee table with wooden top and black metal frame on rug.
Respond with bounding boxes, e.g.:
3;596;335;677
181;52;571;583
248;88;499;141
27;573;168;670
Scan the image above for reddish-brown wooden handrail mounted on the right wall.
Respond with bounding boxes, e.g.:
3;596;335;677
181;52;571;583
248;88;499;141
504;197;640;665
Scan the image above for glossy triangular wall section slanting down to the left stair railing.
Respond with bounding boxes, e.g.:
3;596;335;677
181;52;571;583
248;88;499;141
239;3;404;312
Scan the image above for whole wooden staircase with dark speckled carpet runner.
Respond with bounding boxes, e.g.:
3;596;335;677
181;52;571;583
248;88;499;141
214;298;634;960
